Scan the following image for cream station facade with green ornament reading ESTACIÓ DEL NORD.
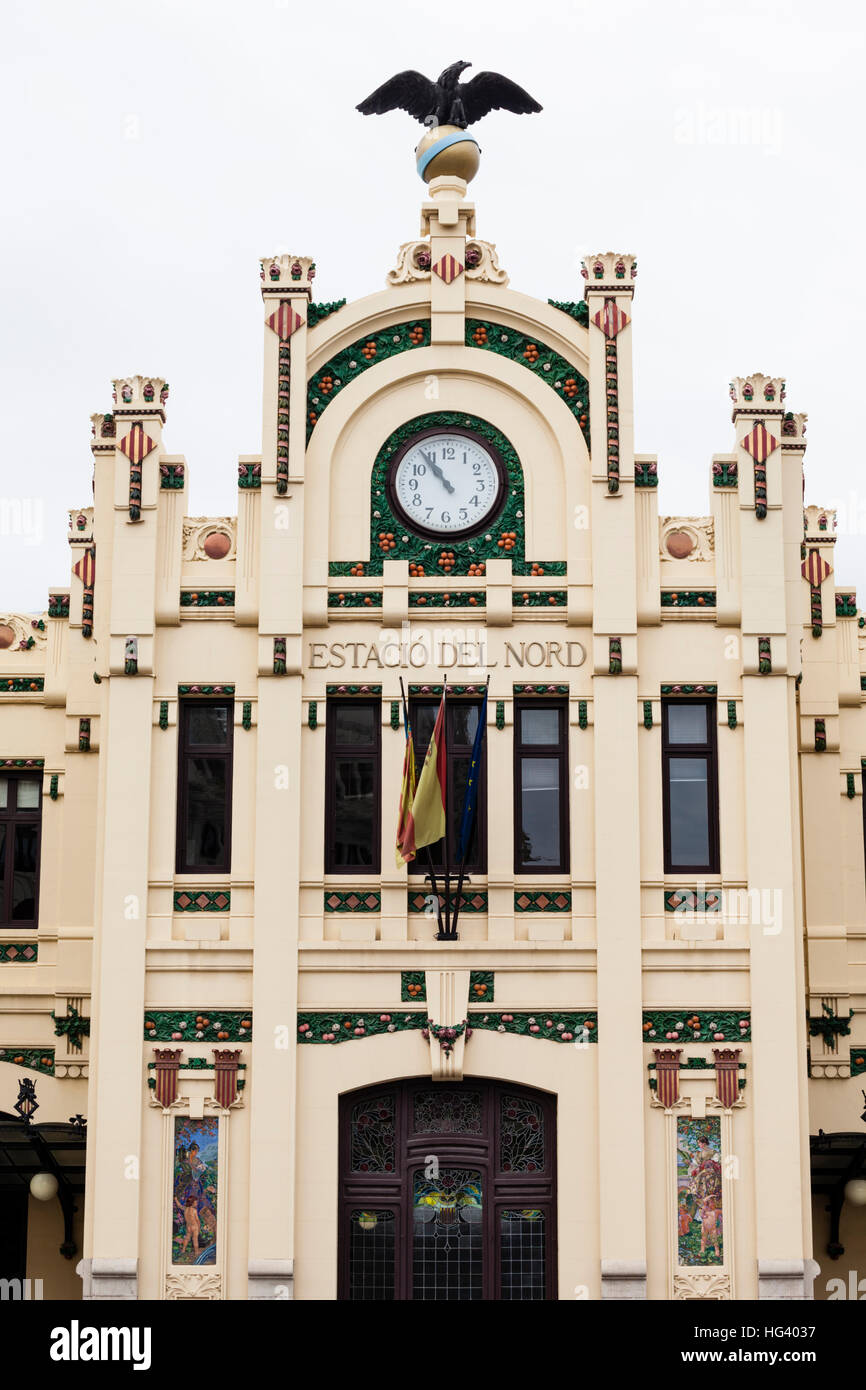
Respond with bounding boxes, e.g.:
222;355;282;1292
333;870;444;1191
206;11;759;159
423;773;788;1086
0;152;866;1300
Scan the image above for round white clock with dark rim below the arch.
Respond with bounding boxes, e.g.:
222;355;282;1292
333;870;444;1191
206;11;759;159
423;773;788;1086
388;428;507;541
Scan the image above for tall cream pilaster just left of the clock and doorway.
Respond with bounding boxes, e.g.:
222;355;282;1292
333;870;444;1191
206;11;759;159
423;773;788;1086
247;256;314;1298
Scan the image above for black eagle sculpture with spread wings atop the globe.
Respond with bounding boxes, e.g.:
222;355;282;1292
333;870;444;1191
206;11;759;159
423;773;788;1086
356;63;541;131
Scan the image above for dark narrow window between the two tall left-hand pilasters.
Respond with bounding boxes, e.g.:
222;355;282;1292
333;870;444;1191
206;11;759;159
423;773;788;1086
177;699;235;873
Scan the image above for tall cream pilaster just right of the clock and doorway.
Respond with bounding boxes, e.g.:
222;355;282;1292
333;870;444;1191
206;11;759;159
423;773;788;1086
586;252;646;1298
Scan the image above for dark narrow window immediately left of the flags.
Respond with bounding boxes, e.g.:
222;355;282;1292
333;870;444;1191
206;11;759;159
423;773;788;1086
325;699;378;874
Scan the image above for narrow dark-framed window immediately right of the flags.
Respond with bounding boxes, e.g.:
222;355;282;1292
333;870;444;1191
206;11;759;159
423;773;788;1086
514;699;569;873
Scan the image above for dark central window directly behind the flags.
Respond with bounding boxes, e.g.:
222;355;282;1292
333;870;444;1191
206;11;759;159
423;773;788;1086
409;699;487;874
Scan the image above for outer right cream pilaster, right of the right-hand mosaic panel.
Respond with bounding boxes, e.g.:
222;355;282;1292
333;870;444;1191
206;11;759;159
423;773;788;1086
731;373;809;1298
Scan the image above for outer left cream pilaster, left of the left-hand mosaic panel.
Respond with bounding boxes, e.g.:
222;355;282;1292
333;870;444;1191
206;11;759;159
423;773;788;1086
86;375;168;1298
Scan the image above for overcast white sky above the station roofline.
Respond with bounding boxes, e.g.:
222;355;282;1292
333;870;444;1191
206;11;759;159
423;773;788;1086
0;0;866;612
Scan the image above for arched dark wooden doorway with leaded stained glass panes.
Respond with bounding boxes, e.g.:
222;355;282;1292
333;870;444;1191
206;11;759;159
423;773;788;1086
338;1080;556;1302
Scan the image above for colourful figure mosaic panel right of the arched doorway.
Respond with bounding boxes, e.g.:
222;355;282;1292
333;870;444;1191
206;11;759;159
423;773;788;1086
677;1115;724;1265
